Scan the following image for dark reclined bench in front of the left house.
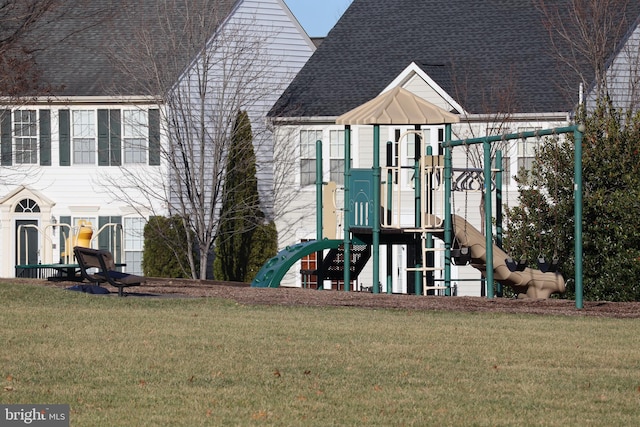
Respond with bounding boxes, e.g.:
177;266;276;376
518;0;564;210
73;246;145;296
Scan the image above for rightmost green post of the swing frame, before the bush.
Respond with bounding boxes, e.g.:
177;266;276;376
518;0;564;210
573;124;585;309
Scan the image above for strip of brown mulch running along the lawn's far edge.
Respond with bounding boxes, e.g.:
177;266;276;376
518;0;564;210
6;279;640;318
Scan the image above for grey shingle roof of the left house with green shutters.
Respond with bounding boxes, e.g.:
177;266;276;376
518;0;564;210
25;0;236;97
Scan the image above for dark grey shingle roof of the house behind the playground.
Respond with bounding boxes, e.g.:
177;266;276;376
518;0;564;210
270;0;640;117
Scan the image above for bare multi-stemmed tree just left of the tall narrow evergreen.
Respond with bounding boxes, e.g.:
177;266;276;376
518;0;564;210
104;0;283;278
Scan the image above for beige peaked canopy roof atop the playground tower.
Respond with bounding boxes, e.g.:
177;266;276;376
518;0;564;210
336;86;460;125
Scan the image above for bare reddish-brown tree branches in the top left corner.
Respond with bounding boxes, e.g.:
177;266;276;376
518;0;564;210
0;0;110;186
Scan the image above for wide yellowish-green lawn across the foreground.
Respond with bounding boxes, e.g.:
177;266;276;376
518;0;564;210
0;285;640;426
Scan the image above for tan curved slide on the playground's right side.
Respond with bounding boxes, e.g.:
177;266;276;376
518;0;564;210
432;215;565;298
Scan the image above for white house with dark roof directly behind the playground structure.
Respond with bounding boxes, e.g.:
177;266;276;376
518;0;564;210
270;0;640;295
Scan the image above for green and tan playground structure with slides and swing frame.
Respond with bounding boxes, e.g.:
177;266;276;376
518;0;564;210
252;88;584;308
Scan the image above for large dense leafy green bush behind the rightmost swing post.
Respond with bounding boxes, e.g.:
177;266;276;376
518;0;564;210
505;103;640;301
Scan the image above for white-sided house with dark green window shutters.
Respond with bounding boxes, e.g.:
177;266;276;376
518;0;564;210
0;0;315;277
